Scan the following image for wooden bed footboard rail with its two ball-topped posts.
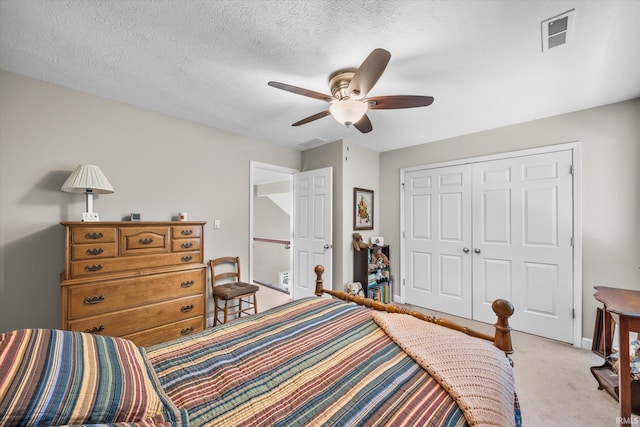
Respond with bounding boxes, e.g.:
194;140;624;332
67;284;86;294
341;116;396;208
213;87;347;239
314;264;514;358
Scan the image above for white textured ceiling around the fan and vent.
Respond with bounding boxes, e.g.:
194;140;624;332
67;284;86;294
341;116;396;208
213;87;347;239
0;0;640;151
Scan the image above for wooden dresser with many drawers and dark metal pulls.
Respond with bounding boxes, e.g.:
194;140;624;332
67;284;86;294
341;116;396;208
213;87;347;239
60;221;207;346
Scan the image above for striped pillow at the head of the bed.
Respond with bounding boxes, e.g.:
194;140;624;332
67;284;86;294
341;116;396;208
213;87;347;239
0;329;188;425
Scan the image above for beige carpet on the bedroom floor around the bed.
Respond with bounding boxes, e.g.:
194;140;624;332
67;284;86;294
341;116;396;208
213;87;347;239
258;287;640;427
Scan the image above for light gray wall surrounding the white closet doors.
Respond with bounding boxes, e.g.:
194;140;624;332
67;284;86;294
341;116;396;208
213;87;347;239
379;99;640;338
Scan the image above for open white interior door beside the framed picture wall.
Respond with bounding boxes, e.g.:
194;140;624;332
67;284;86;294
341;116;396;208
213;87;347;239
292;167;333;299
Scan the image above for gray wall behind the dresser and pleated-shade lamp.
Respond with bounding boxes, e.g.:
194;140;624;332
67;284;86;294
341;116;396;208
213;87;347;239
0;71;301;331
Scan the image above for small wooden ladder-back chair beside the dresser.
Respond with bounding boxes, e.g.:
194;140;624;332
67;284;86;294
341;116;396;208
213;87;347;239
209;257;260;326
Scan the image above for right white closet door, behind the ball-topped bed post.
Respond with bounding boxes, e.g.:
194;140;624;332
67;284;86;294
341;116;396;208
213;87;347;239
472;151;573;342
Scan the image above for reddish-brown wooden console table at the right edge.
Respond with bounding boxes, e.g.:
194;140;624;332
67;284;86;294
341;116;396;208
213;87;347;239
591;286;640;425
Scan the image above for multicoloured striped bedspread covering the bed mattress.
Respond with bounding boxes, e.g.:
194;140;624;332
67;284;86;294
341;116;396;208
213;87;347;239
146;298;467;427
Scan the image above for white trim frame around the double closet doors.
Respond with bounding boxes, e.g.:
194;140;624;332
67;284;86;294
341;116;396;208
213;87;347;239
400;141;582;348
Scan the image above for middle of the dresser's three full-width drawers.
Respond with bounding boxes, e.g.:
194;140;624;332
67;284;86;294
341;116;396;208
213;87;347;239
67;269;205;319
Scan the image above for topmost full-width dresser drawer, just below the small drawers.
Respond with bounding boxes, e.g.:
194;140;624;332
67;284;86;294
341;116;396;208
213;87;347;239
71;251;202;278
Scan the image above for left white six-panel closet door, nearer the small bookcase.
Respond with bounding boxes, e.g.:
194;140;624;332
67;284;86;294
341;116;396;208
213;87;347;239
404;165;472;318
